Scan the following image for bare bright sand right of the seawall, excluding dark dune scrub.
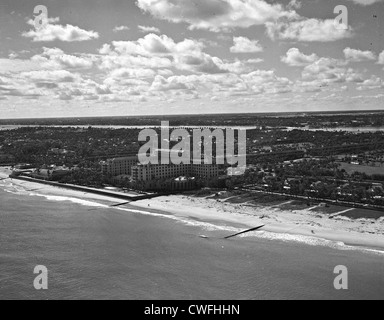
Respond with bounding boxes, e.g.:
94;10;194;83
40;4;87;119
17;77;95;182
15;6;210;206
134;196;384;250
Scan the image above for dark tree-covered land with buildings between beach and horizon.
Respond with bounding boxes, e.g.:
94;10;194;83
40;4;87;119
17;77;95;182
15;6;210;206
0;112;384;210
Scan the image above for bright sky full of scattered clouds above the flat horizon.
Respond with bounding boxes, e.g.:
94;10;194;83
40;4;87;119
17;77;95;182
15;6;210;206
0;0;384;119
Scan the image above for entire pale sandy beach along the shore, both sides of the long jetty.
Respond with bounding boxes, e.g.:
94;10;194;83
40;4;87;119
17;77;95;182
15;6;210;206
0;167;384;251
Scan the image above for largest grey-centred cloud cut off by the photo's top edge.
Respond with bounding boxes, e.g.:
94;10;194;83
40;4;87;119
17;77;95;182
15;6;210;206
137;0;298;32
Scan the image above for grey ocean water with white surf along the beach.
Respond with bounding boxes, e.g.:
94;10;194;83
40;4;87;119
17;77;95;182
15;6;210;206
0;182;384;299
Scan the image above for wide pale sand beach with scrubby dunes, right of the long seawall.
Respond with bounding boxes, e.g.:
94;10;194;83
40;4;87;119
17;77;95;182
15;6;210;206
134;195;384;249
